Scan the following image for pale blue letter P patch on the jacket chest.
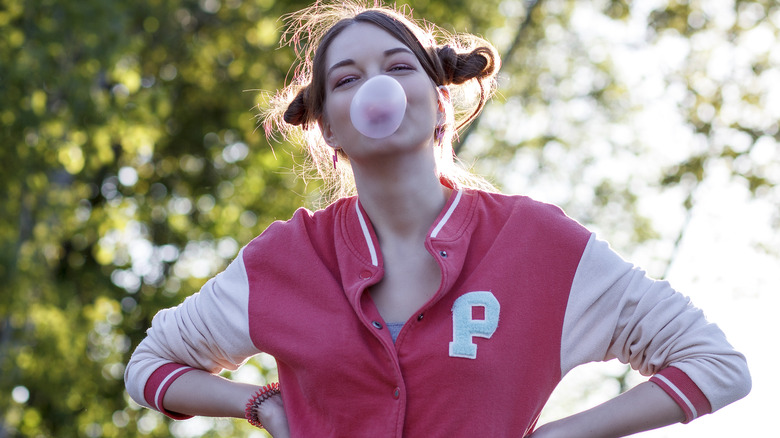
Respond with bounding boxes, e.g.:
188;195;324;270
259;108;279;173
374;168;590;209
450;291;501;359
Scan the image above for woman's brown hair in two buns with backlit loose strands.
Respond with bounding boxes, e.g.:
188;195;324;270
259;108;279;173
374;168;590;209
264;1;500;204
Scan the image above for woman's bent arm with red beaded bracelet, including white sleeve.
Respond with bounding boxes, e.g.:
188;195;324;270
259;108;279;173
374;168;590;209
125;246;286;436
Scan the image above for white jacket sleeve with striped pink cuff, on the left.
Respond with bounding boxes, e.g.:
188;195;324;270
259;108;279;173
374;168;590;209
125;249;259;418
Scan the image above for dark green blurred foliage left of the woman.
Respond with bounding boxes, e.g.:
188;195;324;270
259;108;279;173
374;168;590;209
0;0;314;437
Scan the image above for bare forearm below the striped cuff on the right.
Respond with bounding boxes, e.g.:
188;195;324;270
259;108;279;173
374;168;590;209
530;382;685;438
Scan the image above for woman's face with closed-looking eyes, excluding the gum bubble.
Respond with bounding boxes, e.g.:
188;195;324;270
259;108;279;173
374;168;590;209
320;23;440;162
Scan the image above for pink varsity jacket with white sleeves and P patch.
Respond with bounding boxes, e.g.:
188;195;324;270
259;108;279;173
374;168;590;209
125;190;750;437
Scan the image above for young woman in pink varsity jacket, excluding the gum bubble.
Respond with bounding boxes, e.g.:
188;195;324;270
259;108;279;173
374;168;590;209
125;2;750;438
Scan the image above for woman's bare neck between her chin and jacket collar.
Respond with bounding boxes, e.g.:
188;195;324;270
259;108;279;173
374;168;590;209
353;149;450;242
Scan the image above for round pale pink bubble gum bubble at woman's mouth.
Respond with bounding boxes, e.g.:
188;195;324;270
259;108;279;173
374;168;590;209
349;75;406;138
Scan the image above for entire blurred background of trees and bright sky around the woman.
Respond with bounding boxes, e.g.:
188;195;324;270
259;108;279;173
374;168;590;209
0;0;780;438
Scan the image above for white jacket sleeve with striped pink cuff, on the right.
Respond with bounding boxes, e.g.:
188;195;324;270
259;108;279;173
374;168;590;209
561;235;751;422
